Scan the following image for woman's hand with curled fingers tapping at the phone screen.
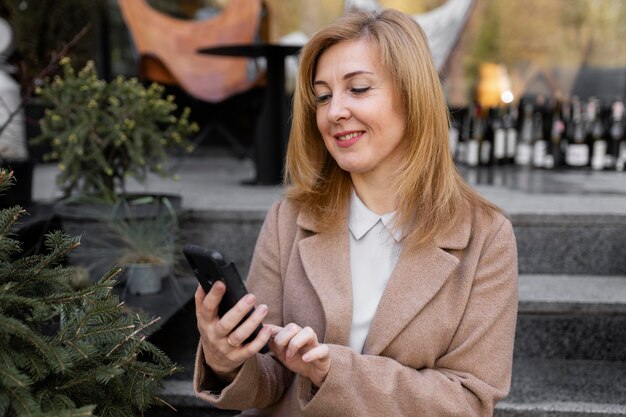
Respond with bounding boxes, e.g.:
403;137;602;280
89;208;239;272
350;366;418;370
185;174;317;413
270;323;330;387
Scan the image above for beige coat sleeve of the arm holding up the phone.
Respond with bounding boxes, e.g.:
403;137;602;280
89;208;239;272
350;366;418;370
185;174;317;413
194;202;293;410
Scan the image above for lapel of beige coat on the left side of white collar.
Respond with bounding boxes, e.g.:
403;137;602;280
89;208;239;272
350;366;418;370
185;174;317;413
298;212;352;345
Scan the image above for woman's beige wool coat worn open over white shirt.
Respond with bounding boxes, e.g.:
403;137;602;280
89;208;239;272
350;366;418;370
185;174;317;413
194;197;517;417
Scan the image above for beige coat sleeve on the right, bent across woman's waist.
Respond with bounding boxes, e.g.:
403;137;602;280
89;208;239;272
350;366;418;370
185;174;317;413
296;217;517;416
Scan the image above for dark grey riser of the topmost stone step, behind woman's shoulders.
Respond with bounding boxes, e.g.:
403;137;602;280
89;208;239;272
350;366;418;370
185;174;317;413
182;209;626;275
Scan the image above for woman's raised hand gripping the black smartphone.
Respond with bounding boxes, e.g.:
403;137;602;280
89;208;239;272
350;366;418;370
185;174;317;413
195;281;271;382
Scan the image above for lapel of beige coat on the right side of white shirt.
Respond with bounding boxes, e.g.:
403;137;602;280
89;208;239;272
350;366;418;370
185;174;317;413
363;211;470;355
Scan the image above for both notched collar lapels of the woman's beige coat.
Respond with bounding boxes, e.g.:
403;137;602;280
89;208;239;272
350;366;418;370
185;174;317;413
297;203;471;355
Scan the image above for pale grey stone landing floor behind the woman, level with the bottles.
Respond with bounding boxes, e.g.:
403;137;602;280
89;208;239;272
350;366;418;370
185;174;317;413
33;148;626;214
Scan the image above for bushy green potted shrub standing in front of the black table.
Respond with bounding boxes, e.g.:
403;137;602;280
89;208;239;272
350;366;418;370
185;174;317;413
33;58;198;276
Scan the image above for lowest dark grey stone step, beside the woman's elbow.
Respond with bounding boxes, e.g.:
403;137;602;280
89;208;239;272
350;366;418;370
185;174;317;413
141;359;626;417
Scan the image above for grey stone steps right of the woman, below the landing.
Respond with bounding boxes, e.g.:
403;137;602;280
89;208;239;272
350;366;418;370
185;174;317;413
495;213;626;417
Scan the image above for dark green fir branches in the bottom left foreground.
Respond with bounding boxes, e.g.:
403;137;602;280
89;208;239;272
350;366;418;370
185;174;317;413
0;170;178;417
